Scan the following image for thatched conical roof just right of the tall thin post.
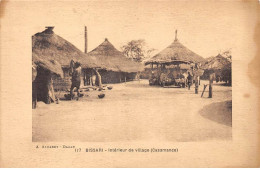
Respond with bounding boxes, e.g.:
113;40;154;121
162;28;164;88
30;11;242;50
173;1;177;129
88;39;144;72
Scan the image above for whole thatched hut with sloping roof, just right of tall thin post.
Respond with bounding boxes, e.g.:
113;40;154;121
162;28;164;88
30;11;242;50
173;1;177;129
88;39;144;83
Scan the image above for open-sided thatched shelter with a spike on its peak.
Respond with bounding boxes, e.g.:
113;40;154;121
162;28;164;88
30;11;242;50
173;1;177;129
145;30;205;86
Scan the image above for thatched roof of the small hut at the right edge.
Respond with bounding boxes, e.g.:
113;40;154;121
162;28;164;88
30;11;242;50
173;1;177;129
202;54;231;70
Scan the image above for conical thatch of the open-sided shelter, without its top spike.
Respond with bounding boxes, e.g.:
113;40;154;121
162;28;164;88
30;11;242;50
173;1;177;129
146;38;205;64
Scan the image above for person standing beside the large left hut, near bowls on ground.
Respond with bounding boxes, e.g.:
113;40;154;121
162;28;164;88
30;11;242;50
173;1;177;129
70;62;81;100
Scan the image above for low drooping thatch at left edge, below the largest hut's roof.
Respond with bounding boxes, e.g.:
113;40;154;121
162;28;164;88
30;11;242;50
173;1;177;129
32;54;63;80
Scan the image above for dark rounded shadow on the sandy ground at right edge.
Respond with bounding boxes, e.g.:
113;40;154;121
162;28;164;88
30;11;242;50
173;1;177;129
199;100;232;127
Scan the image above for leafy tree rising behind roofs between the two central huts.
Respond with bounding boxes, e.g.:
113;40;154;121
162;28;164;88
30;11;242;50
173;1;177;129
121;39;155;62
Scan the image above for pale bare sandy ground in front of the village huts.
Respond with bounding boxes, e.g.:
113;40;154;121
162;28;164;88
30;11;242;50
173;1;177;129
32;80;232;142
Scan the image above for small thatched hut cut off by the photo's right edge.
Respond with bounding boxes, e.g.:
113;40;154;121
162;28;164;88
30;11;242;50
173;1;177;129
202;54;231;84
